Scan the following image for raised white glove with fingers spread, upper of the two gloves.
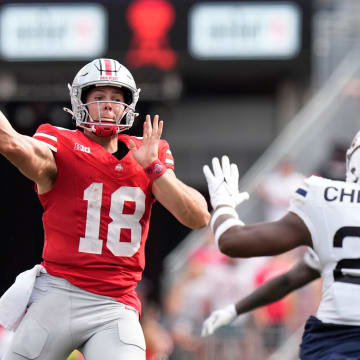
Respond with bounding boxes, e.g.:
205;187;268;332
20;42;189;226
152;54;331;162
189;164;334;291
203;155;249;209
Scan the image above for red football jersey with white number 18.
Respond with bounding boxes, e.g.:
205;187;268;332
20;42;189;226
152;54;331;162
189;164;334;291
34;124;174;313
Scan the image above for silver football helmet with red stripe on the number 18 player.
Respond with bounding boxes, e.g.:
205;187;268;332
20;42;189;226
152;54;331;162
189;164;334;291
64;59;140;136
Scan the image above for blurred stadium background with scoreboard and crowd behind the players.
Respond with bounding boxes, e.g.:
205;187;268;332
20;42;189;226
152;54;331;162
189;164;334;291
0;0;360;360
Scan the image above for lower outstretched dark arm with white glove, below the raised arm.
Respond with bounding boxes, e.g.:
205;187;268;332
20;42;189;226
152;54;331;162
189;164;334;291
201;259;320;336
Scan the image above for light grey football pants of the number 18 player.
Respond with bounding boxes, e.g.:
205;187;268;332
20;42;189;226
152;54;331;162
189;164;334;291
4;273;146;360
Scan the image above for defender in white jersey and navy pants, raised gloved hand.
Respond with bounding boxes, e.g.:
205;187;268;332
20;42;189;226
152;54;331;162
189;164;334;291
204;132;360;360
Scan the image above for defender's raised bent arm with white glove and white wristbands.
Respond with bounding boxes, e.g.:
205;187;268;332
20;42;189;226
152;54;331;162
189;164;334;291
204;156;312;257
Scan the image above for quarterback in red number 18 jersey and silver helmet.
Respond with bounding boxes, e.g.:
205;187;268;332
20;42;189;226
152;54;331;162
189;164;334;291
0;59;210;360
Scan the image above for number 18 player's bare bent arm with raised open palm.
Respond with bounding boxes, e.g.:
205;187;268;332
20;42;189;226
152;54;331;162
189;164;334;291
130;115;210;229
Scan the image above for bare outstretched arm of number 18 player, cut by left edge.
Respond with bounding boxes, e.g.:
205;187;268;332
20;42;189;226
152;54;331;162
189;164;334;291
0;111;57;193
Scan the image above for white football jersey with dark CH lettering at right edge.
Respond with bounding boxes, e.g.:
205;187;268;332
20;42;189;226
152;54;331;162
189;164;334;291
290;176;360;326
